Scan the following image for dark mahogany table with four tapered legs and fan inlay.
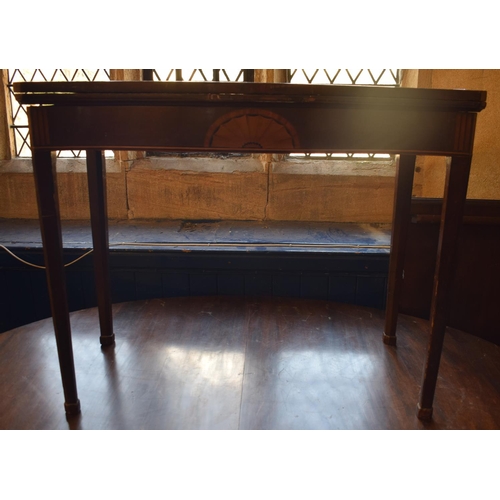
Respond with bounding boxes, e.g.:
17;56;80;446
14;82;486;419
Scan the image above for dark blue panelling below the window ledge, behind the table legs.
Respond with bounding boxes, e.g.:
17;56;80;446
0;249;388;331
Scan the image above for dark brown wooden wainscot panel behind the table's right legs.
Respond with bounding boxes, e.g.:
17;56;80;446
400;199;500;345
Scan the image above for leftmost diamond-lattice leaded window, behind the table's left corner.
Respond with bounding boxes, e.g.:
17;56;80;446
8;69;110;158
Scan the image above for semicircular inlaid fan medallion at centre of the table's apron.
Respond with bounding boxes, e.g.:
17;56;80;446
205;109;299;151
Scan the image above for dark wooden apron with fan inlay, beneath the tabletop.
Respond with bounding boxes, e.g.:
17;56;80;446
28;105;476;156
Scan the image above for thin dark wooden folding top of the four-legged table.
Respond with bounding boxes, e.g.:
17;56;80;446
14;81;486;111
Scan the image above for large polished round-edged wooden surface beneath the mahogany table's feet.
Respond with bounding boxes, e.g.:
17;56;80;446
0;297;500;429
